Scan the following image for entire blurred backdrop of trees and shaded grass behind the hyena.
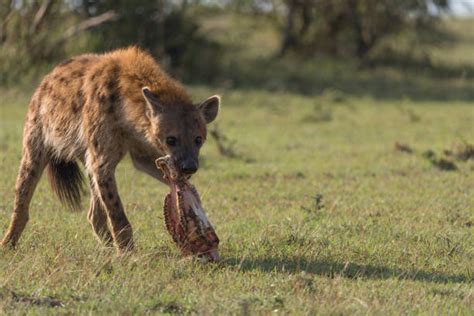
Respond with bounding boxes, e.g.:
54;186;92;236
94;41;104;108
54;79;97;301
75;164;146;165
0;0;474;100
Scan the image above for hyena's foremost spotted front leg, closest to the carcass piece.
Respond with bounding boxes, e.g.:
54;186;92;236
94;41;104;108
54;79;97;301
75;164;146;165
87;154;134;252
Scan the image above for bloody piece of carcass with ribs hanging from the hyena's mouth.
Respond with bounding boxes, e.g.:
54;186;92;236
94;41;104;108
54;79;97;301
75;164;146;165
155;156;220;262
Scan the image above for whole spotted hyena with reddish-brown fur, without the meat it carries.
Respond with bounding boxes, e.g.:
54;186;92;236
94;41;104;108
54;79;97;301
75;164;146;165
2;47;220;251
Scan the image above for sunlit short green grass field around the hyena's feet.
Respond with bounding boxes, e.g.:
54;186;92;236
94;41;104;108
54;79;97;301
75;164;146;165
0;17;474;314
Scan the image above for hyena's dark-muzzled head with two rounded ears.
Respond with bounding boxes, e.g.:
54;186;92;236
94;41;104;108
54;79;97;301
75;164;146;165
142;87;220;175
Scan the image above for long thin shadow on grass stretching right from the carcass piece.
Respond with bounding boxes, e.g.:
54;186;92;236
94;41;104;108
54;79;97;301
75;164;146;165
222;258;474;283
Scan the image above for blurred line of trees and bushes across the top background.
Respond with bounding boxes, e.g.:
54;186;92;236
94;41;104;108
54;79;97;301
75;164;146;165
0;0;449;84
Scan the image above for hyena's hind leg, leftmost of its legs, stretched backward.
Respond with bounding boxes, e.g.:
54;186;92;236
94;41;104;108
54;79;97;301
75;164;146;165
1;127;47;248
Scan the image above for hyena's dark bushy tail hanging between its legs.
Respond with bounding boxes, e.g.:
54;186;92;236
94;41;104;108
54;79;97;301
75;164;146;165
48;159;84;210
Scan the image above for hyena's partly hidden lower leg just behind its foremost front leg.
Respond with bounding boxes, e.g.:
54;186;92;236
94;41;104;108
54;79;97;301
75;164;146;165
87;181;113;246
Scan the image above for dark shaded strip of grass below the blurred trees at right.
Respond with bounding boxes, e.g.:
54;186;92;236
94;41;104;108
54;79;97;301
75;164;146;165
206;58;474;101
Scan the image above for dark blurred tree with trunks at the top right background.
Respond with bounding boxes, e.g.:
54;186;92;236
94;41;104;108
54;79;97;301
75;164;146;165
280;0;448;58
